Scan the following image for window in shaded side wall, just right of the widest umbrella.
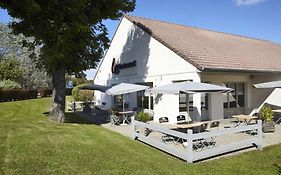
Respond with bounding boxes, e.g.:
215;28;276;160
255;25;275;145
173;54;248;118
223;83;245;108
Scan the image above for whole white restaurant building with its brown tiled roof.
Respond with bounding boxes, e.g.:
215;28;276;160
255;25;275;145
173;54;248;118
94;15;281;122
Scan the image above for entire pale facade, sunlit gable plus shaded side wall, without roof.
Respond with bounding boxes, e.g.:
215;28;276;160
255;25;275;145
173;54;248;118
94;18;280;123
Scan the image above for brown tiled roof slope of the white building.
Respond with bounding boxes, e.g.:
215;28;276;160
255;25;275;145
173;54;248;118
125;15;281;72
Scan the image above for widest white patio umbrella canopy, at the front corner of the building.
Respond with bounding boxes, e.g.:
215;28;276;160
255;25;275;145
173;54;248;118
151;81;233;94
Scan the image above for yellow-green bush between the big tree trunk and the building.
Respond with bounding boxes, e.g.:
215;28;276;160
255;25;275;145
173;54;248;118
72;84;94;101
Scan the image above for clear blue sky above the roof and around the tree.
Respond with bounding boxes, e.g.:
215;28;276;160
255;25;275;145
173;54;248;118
0;0;281;76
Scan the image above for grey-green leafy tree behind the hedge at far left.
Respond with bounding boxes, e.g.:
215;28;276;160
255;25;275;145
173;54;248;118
0;24;51;88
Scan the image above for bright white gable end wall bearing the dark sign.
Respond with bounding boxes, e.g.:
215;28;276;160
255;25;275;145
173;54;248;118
94;18;201;122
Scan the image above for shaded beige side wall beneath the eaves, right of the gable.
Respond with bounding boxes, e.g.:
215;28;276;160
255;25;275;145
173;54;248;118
201;72;281;120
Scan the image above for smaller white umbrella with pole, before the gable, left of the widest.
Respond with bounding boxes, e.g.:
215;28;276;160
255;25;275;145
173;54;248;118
105;83;150;111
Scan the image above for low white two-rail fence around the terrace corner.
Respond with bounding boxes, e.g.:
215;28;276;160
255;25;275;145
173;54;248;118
131;117;263;163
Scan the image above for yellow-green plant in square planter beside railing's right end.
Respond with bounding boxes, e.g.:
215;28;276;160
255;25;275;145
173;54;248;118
261;107;275;133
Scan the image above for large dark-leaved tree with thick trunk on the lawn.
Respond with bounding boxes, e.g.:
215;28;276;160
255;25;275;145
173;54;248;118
0;0;135;122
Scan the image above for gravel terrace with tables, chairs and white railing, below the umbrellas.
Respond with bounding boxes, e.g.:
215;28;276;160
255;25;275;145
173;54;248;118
96;108;281;161
